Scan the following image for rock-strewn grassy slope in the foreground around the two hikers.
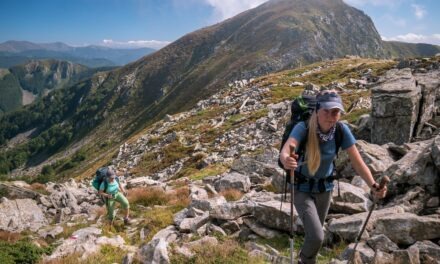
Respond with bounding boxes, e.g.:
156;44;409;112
0;55;440;263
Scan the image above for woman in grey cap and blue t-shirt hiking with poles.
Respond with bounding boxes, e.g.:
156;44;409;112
280;91;387;264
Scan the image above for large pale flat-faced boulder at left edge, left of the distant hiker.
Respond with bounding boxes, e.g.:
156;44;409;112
0;199;48;232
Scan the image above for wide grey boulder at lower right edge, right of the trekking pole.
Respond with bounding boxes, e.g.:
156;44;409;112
374;213;440;245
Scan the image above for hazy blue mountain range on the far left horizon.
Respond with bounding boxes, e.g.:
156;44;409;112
0;41;155;68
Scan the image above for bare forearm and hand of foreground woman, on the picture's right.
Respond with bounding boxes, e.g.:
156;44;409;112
347;145;387;198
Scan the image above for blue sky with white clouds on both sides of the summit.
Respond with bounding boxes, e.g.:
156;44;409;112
0;0;440;48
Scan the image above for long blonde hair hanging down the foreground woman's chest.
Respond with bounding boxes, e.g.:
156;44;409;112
306;111;321;176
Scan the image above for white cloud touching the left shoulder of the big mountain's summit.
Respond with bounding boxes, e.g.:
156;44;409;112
203;0;268;21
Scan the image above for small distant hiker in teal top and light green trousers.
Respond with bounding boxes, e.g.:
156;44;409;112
98;169;130;225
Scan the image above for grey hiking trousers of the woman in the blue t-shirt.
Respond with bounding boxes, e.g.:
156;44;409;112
294;191;332;264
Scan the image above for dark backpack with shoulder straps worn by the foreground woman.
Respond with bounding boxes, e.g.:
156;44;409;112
278;95;343;195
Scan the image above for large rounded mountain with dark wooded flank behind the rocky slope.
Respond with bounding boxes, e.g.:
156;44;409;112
0;0;440;177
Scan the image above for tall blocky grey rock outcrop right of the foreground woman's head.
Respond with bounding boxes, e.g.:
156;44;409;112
371;68;422;144
